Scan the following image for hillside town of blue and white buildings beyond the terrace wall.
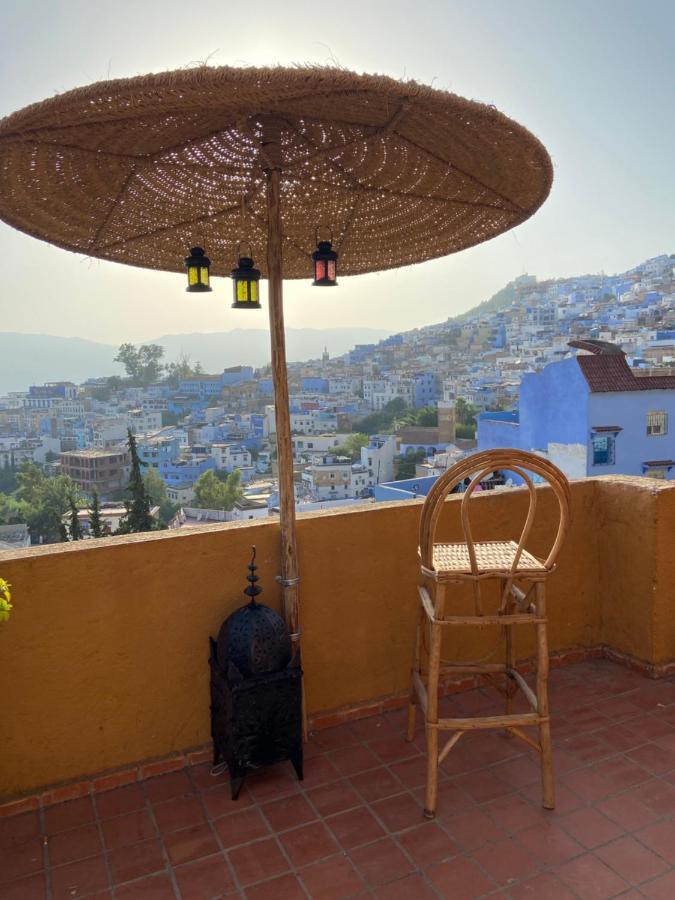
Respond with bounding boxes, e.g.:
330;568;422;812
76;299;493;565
0;255;675;549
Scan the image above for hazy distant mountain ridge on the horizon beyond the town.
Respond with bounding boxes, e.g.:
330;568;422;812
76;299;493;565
0;328;391;394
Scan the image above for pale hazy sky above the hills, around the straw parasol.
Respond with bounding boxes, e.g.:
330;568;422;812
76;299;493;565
0;0;675;344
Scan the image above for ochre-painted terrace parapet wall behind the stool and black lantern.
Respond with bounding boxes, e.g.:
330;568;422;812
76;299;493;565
0;479;675;796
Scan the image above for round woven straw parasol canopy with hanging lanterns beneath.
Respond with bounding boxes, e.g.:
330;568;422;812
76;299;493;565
0;67;552;278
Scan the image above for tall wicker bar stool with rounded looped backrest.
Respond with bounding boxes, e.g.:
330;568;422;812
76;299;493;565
408;450;570;818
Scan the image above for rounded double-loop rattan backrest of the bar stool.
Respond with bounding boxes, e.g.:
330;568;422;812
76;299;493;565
419;449;570;575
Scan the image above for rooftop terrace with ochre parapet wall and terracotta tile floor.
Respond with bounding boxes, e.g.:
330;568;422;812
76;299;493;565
0;478;675;900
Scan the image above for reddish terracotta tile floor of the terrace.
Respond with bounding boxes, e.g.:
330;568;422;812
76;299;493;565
0;661;675;900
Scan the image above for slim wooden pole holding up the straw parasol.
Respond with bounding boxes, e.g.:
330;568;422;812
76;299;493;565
262;122;307;739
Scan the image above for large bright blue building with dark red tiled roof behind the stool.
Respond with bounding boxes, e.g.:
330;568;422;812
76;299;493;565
477;348;675;479
